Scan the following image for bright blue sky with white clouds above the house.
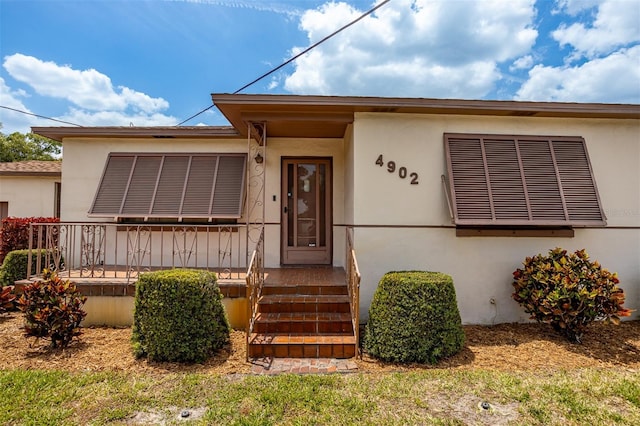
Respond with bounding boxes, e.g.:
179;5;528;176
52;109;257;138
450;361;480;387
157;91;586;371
0;0;640;134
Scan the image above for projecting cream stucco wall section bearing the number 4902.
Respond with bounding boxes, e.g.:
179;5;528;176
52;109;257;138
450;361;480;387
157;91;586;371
350;113;640;324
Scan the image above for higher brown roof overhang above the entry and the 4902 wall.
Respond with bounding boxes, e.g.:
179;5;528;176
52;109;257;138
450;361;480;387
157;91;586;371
211;93;640;138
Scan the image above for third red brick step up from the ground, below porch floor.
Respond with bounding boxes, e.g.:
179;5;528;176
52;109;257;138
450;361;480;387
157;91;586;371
258;294;351;313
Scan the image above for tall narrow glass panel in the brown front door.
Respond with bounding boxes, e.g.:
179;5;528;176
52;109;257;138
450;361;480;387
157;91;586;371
296;163;318;247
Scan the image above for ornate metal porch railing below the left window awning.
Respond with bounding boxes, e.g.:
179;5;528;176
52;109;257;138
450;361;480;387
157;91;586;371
27;222;247;282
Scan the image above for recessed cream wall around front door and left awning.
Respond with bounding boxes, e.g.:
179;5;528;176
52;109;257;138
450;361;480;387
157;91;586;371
61;138;345;267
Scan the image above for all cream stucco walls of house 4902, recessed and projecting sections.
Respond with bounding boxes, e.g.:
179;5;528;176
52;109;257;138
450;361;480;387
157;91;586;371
62;113;640;324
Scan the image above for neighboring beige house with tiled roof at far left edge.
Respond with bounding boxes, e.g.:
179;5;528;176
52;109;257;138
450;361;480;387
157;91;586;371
0;160;62;221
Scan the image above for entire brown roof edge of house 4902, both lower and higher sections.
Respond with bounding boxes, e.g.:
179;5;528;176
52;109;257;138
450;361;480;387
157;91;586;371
32;93;640;141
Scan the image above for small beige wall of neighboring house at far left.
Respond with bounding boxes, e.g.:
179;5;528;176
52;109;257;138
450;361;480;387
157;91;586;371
0;176;60;217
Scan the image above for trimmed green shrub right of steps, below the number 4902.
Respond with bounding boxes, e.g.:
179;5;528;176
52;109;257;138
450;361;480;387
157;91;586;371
364;271;464;364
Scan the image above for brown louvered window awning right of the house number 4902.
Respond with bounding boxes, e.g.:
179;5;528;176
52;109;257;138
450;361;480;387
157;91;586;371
444;134;606;226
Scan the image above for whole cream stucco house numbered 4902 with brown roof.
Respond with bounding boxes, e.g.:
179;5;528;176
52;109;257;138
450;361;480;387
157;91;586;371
33;94;640;355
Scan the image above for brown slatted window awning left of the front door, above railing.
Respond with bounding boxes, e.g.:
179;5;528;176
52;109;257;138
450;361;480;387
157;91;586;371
89;153;247;220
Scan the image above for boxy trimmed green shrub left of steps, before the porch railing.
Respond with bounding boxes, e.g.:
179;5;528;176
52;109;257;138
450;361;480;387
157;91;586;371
132;269;230;362
